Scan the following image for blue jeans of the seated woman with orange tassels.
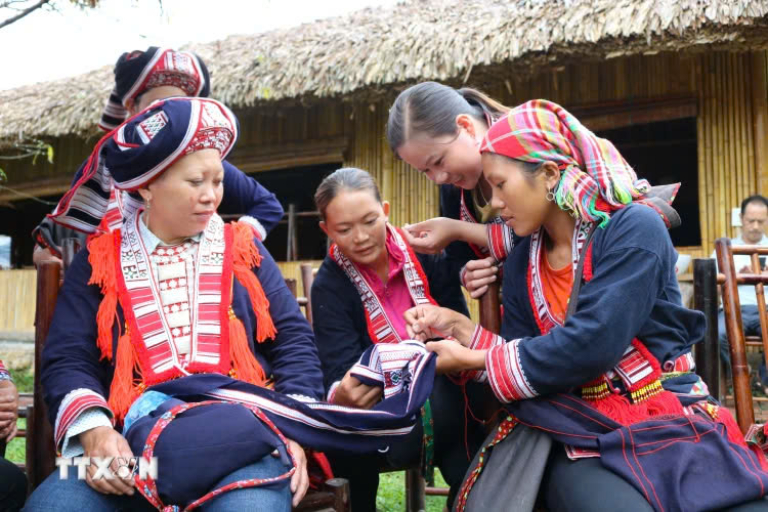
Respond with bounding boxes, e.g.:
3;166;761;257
24;455;291;512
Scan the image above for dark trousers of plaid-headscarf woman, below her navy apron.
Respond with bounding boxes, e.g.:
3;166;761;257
539;443;768;512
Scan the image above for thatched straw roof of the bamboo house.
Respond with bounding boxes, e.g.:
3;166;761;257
0;0;768;143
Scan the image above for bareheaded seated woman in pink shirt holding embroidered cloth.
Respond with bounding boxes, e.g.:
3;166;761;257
312;168;481;511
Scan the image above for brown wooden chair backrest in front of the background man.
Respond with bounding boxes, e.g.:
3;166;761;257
715;238;768;433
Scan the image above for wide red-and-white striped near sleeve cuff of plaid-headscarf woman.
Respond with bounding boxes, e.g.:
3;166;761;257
485;339;538;403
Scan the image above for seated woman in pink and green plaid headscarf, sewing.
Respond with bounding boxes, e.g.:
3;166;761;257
406;100;768;511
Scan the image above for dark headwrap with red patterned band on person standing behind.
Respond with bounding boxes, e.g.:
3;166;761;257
99;46;211;132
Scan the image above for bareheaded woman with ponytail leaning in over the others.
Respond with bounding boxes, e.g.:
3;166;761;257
387;82;514;298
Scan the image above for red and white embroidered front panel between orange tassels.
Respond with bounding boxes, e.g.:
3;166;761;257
120;211;228;385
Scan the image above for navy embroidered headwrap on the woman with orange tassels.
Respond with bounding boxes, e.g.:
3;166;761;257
48;98;238;233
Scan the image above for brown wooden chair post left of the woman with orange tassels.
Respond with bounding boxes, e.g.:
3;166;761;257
26;261;61;489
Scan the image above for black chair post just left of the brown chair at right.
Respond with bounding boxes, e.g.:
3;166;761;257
693;258;720;400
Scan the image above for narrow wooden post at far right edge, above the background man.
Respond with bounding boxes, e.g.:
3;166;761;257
751;51;768;195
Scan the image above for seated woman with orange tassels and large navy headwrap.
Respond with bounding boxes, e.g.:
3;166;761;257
28;98;323;511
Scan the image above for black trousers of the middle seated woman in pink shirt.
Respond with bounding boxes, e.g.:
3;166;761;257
326;375;484;512
